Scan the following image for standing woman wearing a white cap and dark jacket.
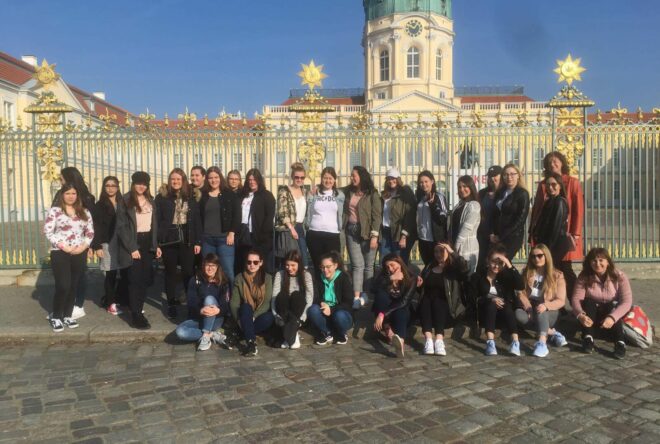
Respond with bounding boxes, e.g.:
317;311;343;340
380;168;417;264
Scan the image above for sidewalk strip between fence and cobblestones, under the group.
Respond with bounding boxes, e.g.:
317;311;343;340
0;272;660;345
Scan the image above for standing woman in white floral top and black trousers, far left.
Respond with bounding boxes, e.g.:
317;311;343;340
44;183;94;332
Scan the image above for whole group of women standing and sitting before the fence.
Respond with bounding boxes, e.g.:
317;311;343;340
44;152;632;358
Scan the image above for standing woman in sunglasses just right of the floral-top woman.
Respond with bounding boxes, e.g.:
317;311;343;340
91;176;125;316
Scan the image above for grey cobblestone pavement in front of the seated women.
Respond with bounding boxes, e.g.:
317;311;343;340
0;338;660;444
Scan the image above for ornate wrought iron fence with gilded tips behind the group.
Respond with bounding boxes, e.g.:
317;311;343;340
0;120;660;268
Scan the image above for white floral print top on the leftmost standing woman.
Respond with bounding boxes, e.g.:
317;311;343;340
44;207;94;251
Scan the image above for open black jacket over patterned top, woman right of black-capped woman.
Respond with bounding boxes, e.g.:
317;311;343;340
155;186;202;246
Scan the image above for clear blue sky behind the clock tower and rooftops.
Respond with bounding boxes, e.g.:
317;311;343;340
0;0;660;116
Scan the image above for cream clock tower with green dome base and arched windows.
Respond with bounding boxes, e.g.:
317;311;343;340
362;0;454;107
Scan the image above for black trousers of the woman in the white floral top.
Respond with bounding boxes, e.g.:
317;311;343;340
50;250;87;320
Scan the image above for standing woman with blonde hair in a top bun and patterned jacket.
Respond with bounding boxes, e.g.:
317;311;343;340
274;162;309;268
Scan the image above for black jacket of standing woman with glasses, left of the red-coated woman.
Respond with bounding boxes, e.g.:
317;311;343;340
493;187;529;259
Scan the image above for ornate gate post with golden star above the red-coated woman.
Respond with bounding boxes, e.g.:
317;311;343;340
548;54;594;174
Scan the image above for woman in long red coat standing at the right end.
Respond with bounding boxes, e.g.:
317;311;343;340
530;151;584;295
